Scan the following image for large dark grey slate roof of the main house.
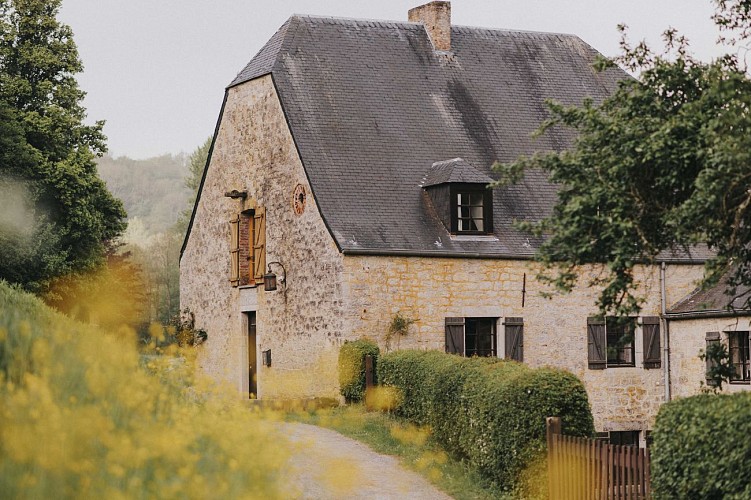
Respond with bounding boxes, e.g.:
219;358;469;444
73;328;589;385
230;15;708;258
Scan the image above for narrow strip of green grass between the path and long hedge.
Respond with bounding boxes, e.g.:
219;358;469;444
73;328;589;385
288;405;507;500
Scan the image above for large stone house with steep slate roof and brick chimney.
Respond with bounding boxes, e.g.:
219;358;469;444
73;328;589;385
180;2;706;442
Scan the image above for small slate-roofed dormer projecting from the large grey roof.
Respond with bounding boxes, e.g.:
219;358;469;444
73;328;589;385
422;158;493;235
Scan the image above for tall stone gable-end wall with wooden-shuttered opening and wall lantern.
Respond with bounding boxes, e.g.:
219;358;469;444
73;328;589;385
180;76;349;397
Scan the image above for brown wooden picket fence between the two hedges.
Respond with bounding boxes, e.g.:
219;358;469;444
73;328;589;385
547;417;650;500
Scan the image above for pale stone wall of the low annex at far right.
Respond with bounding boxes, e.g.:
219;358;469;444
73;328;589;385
670;316;751;397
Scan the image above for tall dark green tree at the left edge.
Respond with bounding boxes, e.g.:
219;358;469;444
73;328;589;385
0;0;125;292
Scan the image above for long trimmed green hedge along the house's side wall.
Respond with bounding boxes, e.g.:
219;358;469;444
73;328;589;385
378;351;594;489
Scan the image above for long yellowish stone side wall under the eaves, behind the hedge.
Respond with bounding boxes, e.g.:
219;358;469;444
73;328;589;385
344;256;702;431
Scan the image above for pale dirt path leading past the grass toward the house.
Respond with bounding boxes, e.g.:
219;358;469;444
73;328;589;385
280;423;451;500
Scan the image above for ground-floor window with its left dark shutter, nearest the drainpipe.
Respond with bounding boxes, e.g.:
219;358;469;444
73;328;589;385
587;316;636;370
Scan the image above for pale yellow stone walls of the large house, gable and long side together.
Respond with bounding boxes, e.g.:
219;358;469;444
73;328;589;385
180;76;703;431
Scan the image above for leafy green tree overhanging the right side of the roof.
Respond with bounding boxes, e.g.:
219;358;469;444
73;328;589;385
497;0;751;315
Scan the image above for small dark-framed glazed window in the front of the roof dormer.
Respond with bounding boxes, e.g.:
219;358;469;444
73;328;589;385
451;184;493;234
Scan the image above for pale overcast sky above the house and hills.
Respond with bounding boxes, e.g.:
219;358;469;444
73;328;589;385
60;0;720;158
